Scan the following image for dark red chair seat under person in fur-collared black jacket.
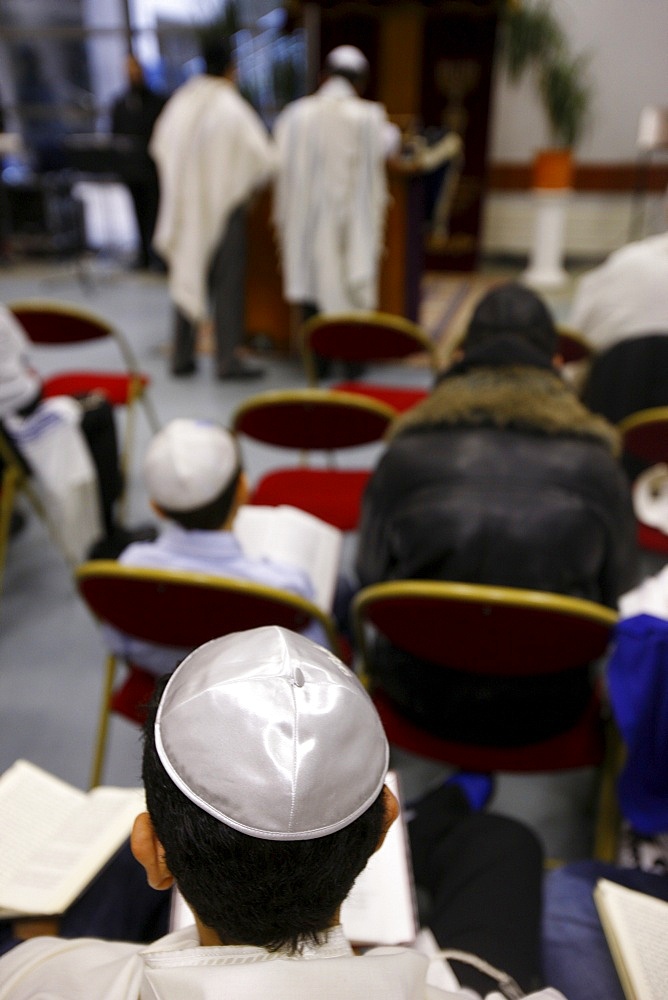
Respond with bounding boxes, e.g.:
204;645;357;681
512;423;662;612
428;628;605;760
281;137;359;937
373;692;604;772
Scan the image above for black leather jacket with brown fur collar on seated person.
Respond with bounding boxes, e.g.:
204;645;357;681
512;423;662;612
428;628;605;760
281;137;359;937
357;367;636;742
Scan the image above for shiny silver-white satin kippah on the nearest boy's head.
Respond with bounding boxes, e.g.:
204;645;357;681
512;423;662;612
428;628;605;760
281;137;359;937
155;626;389;840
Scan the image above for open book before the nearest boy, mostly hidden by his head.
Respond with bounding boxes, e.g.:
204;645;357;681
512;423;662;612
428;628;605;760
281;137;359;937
171;771;417;945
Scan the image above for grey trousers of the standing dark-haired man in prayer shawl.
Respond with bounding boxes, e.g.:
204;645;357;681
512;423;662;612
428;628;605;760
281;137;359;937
172;205;247;371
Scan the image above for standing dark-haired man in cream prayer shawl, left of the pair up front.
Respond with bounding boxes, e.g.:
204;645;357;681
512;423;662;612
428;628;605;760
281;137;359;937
149;37;275;378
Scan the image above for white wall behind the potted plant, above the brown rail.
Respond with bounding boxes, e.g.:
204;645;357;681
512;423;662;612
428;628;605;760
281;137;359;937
490;0;668;163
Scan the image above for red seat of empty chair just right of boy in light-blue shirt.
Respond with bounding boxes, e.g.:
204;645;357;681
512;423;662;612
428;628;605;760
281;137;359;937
250;468;371;531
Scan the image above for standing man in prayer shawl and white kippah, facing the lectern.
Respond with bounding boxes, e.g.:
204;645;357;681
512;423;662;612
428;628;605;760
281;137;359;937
274;45;400;318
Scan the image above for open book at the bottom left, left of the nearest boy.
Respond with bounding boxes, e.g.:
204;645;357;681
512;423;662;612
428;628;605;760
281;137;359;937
0;760;146;919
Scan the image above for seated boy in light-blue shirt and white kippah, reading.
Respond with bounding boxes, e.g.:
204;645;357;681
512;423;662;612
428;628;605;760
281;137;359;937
105;418;327;674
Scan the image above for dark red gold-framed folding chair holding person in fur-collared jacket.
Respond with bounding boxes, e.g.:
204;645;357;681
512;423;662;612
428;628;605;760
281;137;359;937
353;580;617;771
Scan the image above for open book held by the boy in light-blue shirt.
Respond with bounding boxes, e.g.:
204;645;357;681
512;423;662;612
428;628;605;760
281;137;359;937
232;504;343;612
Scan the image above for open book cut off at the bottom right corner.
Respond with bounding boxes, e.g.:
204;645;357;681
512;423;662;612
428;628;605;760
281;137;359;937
594;879;668;1000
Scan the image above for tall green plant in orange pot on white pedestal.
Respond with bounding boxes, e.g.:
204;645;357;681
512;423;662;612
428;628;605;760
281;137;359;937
501;0;592;188
